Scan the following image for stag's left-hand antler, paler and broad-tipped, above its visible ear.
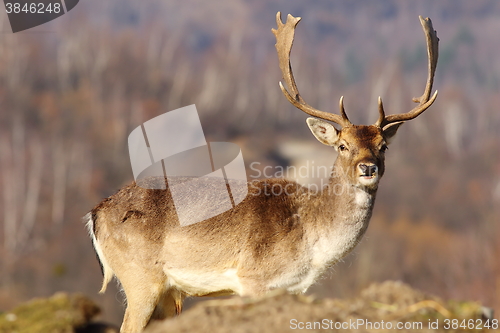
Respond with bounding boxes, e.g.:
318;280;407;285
272;12;351;127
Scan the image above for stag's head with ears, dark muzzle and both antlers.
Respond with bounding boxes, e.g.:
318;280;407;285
272;12;439;190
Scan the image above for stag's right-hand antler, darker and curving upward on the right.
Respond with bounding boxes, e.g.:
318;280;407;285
375;16;439;128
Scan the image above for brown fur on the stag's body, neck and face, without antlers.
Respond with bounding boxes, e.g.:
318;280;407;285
86;125;400;332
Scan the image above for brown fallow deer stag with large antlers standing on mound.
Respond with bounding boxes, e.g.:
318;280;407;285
85;12;438;333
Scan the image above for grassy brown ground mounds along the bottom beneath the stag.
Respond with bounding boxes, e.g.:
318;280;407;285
0;281;492;333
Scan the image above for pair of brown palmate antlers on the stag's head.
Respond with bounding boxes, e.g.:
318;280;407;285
272;12;439;128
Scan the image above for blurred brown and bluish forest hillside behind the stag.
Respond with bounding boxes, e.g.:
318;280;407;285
0;0;500;323
